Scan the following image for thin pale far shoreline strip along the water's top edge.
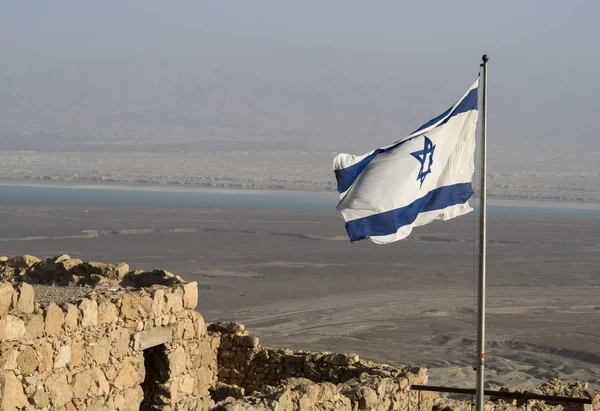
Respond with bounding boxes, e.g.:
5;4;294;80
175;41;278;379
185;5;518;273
0;180;600;210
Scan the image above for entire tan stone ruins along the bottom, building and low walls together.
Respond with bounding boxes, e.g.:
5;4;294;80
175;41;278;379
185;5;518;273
0;255;600;411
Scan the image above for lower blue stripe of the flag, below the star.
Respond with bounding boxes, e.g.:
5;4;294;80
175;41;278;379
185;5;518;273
346;183;473;242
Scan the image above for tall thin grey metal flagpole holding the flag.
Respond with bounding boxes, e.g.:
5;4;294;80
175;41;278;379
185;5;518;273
475;54;488;411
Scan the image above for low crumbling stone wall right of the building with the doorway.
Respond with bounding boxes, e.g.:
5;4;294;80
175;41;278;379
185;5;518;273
208;323;435;411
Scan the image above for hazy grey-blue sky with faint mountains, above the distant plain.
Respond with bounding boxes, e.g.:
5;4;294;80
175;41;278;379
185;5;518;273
0;1;600;156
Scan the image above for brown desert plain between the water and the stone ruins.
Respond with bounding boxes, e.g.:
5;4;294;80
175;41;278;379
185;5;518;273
0;205;600;387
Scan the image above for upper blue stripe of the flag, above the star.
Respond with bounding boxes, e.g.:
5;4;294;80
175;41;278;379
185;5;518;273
335;88;477;193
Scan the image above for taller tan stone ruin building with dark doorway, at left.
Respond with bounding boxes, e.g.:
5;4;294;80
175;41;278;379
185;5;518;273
0;257;218;411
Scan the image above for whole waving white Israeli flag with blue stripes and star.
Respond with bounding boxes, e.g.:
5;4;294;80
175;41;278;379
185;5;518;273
333;80;479;244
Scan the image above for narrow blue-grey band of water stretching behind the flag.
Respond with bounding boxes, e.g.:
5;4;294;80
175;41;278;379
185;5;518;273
0;185;600;219
